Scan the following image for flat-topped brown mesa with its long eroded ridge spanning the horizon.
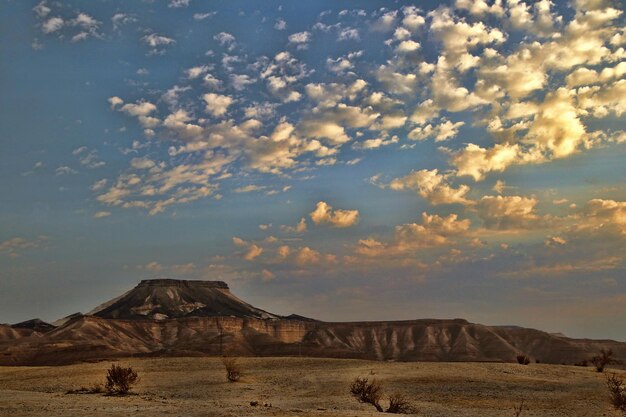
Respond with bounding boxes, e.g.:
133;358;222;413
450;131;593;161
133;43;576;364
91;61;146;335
0;279;626;365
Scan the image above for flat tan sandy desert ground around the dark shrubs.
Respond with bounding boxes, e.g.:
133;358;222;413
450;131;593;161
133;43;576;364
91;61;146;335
0;358;626;417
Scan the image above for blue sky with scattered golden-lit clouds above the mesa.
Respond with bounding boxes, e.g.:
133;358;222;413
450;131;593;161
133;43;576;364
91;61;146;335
0;0;626;341
